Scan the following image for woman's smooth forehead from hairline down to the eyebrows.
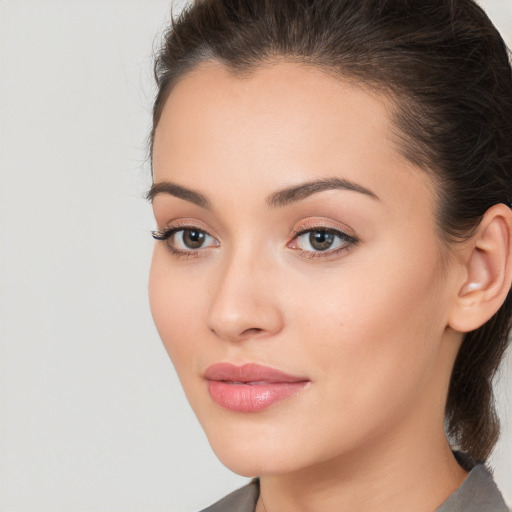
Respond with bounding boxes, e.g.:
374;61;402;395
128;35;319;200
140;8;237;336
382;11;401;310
153;62;433;216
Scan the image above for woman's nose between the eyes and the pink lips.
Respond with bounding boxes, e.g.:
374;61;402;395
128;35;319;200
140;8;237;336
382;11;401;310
207;249;283;342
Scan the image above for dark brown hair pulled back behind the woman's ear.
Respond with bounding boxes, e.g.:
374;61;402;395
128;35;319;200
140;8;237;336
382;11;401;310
150;0;512;461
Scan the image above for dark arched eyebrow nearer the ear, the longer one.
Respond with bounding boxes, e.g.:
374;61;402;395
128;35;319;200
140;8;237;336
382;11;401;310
267;178;379;208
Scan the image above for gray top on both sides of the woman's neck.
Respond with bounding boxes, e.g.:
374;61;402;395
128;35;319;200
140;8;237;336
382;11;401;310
202;464;512;512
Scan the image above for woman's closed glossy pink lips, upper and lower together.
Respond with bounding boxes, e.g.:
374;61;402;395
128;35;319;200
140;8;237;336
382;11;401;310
204;363;310;412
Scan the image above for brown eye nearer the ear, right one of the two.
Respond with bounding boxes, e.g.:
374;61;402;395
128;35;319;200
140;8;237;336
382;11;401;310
289;227;357;257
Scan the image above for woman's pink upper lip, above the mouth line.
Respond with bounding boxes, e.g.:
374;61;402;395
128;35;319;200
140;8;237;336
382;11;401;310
203;363;309;383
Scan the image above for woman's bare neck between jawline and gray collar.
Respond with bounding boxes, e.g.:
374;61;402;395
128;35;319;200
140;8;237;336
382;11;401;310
257;432;467;512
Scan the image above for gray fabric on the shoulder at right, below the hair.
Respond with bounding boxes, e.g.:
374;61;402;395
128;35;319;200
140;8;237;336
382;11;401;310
436;464;510;512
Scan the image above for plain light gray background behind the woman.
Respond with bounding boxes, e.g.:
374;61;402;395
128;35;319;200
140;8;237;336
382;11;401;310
0;0;512;512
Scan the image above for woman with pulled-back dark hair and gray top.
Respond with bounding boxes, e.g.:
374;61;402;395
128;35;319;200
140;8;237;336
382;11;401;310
148;0;512;512
